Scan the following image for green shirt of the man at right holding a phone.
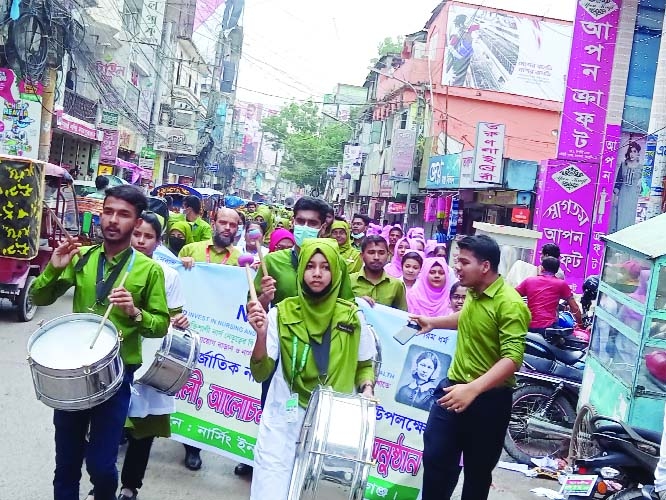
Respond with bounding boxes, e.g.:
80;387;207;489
448;276;530;386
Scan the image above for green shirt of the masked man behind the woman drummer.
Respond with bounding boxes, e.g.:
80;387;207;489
254;248;354;305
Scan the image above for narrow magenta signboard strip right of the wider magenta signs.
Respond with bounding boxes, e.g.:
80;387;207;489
585;124;622;276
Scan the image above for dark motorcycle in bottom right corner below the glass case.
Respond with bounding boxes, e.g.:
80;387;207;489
569;415;661;500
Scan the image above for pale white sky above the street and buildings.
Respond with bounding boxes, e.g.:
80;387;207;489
230;0;576;106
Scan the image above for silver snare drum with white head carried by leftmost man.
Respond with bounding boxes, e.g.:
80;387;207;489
28;313;123;410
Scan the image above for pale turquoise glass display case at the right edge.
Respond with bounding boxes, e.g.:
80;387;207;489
579;214;666;432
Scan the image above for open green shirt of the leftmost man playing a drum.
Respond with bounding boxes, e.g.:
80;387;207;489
30;246;169;365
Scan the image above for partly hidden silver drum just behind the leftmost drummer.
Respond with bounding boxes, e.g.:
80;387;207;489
134;326;201;396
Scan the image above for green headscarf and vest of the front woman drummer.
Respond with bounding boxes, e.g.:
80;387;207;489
250;238;375;408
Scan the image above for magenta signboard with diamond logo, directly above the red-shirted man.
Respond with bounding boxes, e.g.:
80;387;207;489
534;160;599;292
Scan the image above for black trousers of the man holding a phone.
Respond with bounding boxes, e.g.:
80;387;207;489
421;379;513;500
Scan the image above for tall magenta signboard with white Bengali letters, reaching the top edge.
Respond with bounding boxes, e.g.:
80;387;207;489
557;0;622;163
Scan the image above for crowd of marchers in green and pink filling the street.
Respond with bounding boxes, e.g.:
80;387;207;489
32;186;596;500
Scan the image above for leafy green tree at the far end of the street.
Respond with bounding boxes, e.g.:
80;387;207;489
262;102;351;187
